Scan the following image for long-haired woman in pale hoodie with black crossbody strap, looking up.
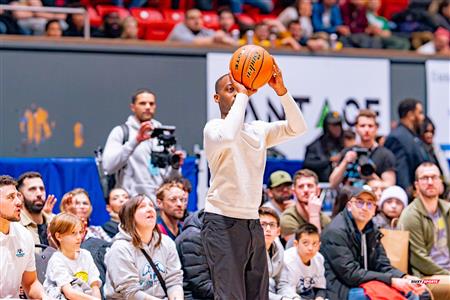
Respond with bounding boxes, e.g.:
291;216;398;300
104;195;183;299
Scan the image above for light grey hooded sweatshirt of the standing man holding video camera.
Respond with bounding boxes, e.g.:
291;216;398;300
103;115;179;201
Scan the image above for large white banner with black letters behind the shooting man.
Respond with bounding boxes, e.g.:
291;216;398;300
207;53;390;160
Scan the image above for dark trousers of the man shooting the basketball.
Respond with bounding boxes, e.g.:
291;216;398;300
202;213;269;300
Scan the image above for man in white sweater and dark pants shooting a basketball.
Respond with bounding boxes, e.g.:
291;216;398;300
202;59;306;300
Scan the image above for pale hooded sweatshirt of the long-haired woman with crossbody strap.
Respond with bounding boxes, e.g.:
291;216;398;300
104;226;183;299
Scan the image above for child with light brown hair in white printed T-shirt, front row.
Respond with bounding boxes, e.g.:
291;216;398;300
44;213;101;299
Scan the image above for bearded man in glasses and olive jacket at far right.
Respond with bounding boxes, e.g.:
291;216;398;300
399;162;450;299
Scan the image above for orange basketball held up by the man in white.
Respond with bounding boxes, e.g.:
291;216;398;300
230;45;273;89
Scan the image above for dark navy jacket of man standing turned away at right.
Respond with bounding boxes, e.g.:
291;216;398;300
384;124;429;191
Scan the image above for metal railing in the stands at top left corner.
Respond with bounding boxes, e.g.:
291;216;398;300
0;5;91;40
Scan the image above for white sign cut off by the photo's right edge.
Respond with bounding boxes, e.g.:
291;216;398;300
426;60;450;154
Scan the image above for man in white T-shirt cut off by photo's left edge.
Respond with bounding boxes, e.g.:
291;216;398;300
0;175;49;299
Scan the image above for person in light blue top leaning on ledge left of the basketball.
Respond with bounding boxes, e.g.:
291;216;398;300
167;8;236;45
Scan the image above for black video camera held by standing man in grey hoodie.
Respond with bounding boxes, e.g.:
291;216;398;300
151;126;181;169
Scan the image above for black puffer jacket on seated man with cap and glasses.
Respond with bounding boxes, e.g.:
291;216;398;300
320;209;405;300
